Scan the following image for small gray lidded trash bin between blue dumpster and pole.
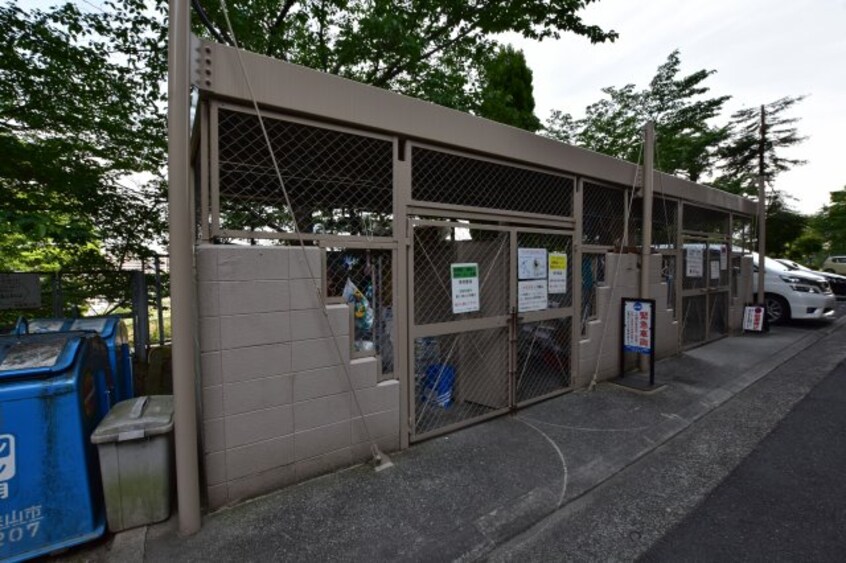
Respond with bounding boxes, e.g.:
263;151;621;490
91;395;173;532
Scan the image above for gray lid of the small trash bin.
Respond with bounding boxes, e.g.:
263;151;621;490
91;395;173;444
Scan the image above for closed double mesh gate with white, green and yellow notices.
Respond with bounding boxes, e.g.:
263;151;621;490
411;221;573;439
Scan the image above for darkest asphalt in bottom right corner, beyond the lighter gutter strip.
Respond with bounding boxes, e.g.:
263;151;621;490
642;364;846;561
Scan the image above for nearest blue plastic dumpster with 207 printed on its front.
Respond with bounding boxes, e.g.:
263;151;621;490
0;332;109;561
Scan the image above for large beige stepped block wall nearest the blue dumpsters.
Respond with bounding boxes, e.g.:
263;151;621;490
197;245;400;509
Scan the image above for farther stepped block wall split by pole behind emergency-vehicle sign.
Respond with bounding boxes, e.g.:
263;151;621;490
574;253;679;387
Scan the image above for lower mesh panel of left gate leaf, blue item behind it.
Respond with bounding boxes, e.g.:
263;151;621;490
414;328;509;437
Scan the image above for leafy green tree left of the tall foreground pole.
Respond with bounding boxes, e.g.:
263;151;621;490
0;0;166;269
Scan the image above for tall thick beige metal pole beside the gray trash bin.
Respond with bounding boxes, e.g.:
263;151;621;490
167;0;201;535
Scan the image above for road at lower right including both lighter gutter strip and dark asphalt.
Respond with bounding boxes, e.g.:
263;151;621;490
488;307;846;563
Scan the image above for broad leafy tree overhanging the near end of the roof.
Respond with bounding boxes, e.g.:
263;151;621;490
194;0;617;111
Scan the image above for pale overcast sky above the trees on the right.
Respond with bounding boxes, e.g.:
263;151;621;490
500;0;846;213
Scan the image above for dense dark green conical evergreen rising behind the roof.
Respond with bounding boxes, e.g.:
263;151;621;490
478;45;541;132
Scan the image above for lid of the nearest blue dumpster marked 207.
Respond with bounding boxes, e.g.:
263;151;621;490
0;333;78;377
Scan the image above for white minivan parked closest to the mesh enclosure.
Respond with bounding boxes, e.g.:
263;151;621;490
752;253;836;323
